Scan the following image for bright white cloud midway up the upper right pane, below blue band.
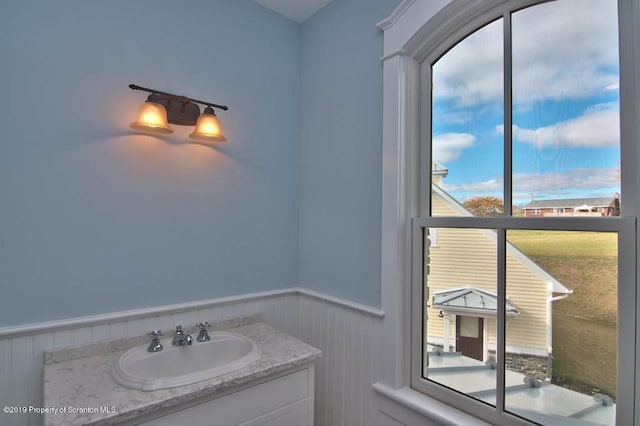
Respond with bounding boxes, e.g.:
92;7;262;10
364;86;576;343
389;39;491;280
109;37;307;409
504;105;620;148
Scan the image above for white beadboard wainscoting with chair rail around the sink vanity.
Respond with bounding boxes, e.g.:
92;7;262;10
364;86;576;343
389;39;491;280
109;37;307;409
0;288;384;426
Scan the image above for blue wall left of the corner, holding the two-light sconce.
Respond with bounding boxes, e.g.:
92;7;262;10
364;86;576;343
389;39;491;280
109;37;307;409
0;0;300;326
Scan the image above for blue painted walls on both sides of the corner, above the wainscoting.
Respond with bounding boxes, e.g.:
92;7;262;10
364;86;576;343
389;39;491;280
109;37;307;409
0;0;398;326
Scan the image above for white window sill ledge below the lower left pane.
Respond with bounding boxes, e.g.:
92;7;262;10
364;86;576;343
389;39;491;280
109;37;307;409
373;383;490;426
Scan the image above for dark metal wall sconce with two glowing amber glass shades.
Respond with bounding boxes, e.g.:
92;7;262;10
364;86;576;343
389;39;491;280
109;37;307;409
129;84;229;142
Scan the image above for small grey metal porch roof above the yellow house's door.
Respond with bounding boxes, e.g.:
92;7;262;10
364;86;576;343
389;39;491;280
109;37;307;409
433;287;520;315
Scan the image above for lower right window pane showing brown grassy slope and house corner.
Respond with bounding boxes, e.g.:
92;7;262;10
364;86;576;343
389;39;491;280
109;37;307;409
505;230;618;425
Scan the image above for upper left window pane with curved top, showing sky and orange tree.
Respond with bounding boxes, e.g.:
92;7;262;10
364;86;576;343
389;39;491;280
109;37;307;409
432;19;504;216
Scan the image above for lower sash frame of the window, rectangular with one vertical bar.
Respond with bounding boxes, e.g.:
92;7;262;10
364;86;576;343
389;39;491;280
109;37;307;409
411;220;635;425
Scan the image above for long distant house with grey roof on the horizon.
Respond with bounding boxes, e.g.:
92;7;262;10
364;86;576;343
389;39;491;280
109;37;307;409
522;194;620;217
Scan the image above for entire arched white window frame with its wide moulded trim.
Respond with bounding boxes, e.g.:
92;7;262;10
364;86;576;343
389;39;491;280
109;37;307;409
374;0;640;425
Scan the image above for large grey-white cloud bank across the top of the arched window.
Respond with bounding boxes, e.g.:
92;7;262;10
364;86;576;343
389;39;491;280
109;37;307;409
433;0;618;107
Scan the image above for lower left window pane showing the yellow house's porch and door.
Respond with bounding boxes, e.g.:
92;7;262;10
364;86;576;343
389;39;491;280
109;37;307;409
423;228;497;403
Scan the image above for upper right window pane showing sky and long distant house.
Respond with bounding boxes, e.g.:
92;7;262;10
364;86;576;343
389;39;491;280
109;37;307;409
512;0;620;217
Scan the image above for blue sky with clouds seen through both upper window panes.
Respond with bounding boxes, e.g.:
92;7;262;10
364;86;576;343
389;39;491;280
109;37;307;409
433;0;620;205
